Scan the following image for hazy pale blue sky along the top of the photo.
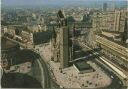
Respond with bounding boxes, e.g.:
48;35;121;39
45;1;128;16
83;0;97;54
2;0;128;6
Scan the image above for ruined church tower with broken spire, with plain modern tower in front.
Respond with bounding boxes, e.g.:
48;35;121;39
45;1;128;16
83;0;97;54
52;10;70;69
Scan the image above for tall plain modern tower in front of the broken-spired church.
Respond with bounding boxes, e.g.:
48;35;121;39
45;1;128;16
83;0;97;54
60;26;69;68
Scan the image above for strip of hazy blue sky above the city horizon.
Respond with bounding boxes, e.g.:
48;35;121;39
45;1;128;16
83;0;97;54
1;0;128;6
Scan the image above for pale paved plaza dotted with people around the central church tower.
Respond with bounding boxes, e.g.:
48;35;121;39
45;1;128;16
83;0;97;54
36;43;112;88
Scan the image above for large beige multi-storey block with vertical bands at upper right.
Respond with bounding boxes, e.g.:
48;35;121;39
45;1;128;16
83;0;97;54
94;10;126;32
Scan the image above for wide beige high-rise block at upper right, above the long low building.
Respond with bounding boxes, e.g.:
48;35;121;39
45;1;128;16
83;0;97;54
93;10;127;44
